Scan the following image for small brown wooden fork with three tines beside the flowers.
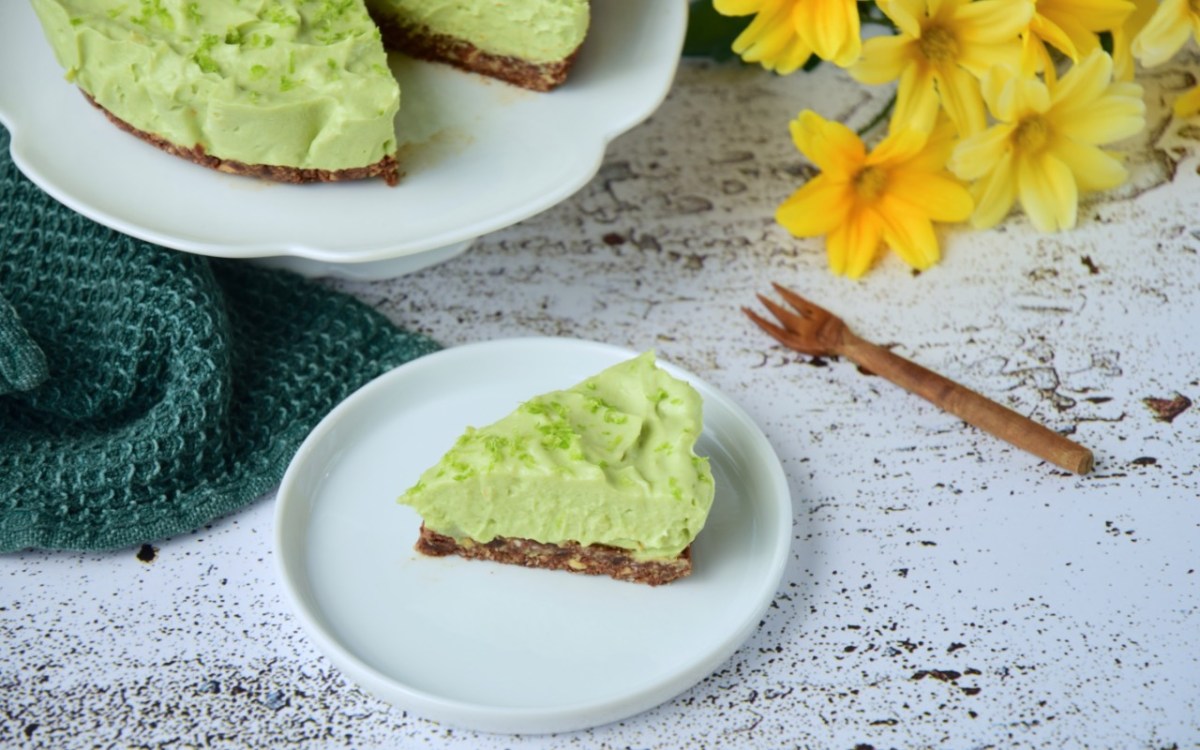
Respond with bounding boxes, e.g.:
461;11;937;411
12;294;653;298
742;284;1093;474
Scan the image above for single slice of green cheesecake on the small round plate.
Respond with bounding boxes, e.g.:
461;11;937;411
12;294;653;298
400;352;714;586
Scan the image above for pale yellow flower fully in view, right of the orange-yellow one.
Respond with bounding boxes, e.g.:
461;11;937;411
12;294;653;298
950;52;1146;232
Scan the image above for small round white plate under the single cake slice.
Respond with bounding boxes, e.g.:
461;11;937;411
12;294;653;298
275;338;792;733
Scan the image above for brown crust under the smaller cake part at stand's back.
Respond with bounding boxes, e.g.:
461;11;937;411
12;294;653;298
376;18;580;91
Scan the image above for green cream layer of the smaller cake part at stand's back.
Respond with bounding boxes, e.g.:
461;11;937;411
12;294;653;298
367;0;589;62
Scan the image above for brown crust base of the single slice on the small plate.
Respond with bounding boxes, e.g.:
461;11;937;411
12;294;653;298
415;523;691;586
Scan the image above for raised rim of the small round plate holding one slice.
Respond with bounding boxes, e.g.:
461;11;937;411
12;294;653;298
272;336;794;734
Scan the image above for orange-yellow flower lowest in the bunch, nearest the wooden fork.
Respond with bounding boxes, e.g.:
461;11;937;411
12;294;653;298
775;109;972;278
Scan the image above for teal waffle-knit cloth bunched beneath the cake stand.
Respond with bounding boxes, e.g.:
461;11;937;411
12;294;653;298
0;128;437;552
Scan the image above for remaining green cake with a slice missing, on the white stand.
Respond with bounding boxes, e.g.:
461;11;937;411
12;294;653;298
32;0;589;184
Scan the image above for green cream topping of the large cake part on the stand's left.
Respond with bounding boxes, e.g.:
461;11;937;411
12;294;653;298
32;0;400;170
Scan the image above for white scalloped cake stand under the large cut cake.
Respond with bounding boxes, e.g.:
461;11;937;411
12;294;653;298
0;0;688;278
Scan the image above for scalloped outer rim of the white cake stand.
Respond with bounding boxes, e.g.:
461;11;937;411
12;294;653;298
0;0;690;265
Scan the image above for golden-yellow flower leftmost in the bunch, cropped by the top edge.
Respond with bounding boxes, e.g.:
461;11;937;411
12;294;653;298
713;0;863;74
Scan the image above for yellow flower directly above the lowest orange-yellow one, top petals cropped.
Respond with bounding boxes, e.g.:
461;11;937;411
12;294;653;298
850;0;1033;134
